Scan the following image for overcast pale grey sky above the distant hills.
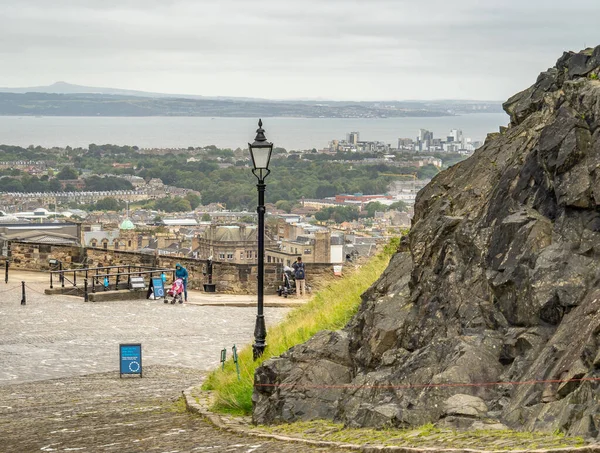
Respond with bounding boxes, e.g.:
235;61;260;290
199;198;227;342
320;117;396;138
0;0;600;100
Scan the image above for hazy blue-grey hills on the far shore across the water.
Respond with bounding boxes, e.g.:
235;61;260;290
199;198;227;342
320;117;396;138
0;82;502;118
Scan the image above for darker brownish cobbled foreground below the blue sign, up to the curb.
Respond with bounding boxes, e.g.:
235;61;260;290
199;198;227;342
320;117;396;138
0;366;339;453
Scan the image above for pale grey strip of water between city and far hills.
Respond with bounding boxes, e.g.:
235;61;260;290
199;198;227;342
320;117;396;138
0;113;509;150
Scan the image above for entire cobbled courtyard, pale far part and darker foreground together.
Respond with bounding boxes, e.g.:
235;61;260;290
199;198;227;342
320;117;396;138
0;275;342;452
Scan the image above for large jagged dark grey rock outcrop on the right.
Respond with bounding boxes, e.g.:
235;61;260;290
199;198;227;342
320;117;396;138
253;46;600;437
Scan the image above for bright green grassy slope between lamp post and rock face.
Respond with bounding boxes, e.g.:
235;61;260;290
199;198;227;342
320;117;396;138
202;240;398;415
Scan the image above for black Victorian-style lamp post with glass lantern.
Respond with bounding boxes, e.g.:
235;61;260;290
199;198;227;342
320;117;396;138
248;120;273;360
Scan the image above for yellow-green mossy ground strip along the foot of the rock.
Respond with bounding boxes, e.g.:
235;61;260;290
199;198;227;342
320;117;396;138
257;420;585;451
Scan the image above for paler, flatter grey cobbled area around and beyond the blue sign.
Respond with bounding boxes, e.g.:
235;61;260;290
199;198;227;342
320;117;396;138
0;281;289;385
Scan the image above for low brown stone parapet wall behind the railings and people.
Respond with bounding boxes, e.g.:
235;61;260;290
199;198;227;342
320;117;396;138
4;241;342;294
